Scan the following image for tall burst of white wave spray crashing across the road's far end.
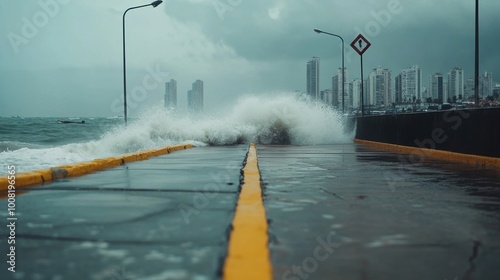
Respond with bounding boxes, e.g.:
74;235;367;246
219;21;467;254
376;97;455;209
124;95;352;145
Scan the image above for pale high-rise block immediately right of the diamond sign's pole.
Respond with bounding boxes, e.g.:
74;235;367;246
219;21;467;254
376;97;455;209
366;66;392;106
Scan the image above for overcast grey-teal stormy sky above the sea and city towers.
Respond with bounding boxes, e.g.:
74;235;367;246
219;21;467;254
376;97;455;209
0;0;500;117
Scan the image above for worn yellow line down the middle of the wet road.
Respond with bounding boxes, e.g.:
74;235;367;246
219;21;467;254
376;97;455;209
223;144;272;280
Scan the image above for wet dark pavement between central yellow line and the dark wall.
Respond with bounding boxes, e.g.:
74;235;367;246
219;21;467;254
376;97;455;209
258;145;500;280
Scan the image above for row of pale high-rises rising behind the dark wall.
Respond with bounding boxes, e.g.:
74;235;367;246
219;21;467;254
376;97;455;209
306;57;500;109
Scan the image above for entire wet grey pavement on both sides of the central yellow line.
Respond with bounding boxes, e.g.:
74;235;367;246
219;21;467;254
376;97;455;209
0;143;500;280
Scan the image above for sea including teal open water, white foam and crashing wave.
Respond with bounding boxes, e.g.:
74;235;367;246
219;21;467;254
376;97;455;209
0;95;353;174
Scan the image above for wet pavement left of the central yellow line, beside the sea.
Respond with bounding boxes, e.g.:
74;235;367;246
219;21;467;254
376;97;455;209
0;146;248;280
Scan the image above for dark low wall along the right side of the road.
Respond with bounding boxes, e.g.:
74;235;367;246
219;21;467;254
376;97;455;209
356;108;500;157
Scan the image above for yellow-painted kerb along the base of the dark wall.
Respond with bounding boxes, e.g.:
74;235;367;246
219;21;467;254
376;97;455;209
354;139;500;168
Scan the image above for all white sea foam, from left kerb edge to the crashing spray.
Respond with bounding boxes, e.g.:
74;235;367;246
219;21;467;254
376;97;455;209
0;94;352;173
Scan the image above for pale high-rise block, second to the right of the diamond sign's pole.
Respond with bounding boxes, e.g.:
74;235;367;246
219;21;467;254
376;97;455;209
396;65;422;103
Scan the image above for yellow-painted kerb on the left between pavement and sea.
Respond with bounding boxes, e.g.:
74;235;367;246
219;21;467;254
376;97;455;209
0;144;193;191
